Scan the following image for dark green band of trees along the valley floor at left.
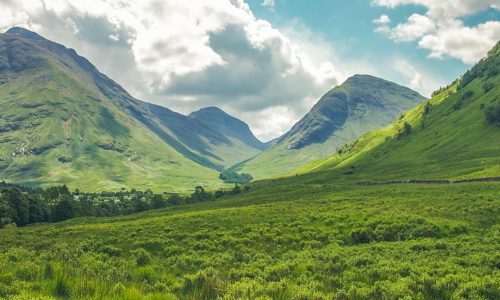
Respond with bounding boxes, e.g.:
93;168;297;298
0;182;250;228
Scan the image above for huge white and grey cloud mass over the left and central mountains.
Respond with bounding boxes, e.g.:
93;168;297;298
0;0;341;139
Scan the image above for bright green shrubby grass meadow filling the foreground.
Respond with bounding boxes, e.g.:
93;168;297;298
0;178;500;299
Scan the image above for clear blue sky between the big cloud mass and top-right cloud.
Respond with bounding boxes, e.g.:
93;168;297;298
248;0;494;96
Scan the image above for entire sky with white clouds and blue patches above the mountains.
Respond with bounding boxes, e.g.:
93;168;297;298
0;0;500;141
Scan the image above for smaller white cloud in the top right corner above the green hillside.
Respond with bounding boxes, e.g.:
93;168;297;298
372;0;500;64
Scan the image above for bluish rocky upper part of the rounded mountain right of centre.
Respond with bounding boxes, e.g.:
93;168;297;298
278;74;425;149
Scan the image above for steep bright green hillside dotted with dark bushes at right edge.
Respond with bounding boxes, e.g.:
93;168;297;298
297;44;500;181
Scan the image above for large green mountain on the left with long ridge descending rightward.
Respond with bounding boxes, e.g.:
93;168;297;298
0;28;261;191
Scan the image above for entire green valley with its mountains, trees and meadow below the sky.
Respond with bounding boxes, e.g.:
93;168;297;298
0;17;500;300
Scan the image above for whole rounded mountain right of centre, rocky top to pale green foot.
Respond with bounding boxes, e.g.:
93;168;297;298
232;75;425;178
